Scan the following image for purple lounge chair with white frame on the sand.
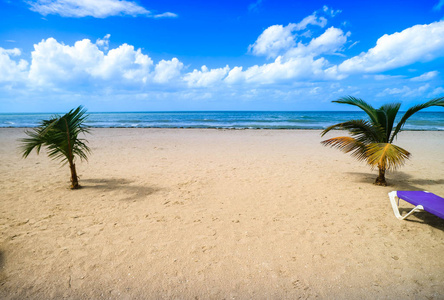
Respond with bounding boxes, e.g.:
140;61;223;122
389;191;444;220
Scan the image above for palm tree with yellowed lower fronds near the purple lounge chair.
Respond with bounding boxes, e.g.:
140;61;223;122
321;96;444;186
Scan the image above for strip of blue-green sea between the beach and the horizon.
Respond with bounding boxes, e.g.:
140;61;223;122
0;111;444;130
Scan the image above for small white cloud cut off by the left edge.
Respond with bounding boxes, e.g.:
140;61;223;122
0;47;28;82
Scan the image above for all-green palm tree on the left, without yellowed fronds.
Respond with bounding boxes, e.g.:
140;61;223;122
20;106;91;189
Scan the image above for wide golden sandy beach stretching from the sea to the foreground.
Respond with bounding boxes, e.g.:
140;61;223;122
0;129;444;299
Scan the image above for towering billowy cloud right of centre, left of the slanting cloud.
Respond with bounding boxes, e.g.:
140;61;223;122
243;24;350;84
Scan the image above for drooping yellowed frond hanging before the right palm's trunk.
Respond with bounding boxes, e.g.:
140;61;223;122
366;143;410;170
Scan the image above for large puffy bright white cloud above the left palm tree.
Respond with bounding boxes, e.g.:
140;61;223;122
29;38;153;86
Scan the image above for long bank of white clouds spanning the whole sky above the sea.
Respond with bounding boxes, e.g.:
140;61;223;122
0;16;444;106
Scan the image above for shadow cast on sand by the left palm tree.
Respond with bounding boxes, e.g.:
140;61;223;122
82;178;160;201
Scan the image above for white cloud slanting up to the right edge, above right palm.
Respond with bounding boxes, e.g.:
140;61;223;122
338;21;444;73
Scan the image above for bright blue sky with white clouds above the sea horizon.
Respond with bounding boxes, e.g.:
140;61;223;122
0;0;444;113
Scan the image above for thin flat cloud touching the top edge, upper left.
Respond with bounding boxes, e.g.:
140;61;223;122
27;0;177;18
